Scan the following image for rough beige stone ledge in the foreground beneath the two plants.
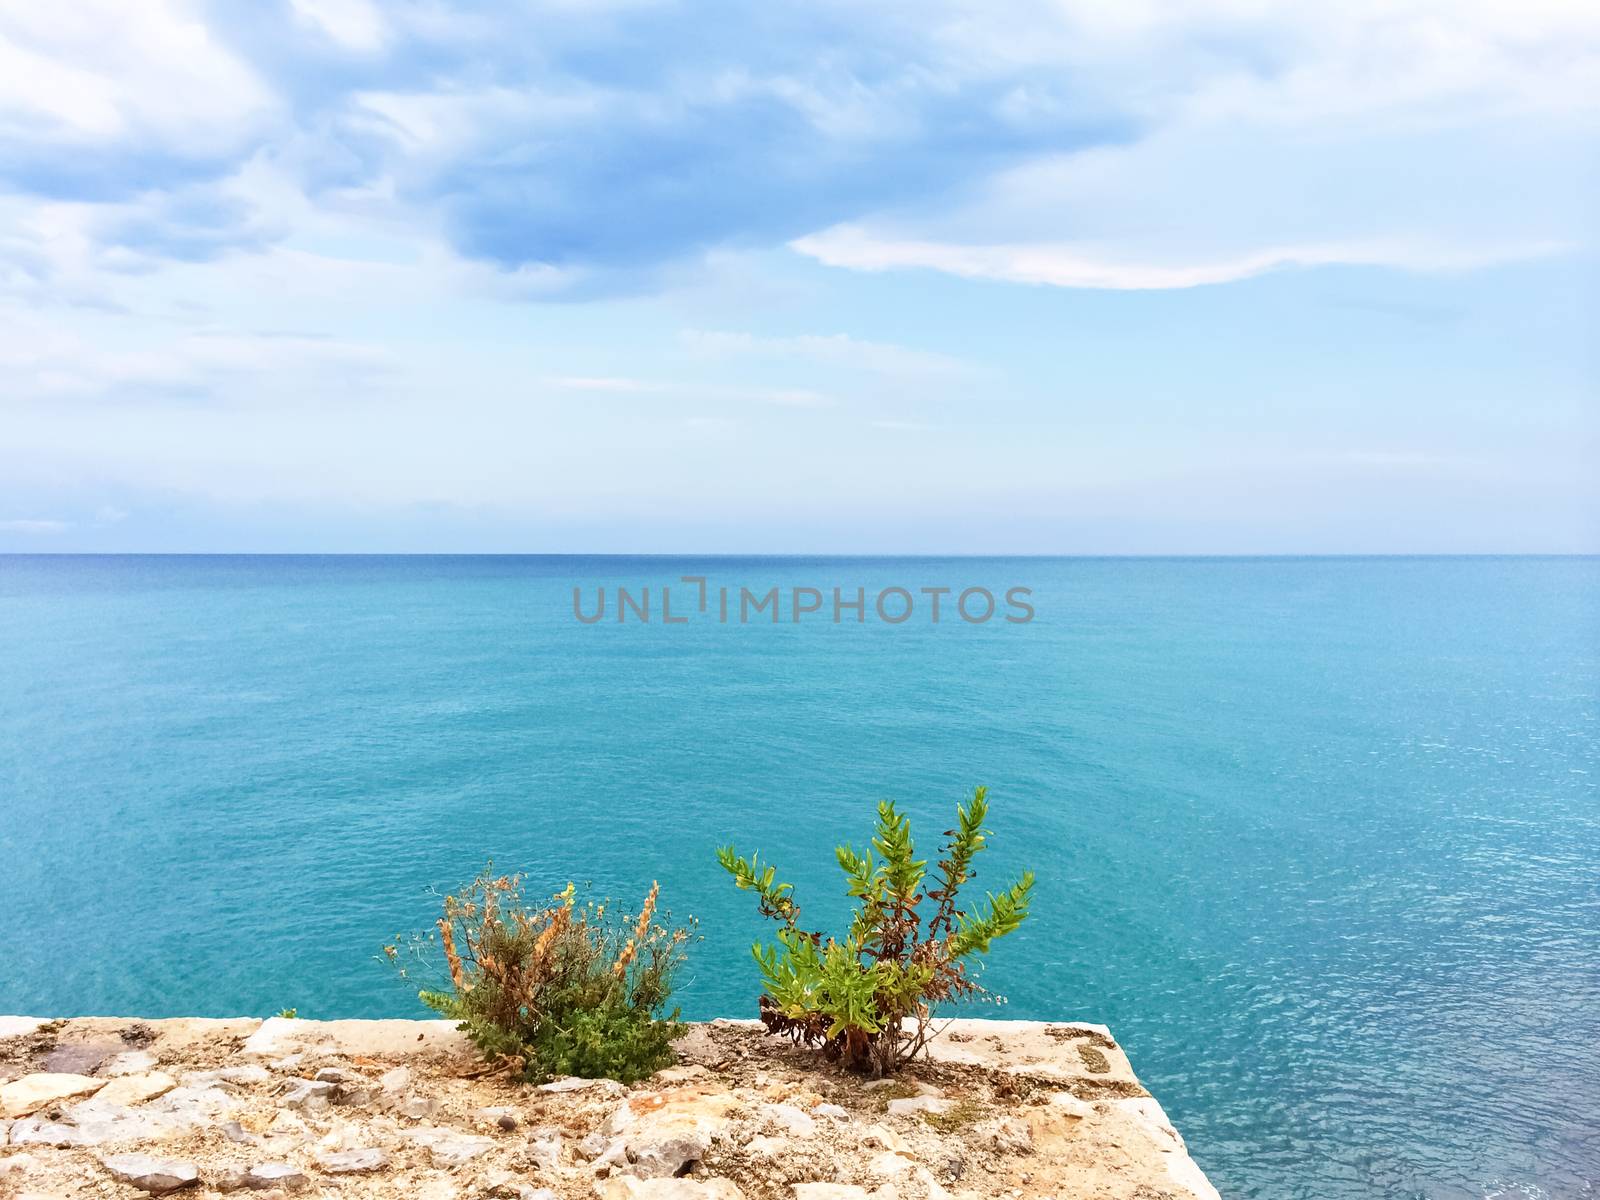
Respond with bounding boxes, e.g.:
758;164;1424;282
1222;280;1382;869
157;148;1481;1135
0;1018;1218;1200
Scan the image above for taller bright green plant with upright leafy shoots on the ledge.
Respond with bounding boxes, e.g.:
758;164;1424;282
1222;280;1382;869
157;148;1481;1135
717;787;1034;1075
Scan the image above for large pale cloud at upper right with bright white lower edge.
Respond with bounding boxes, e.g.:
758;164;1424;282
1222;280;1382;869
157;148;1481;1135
790;0;1600;290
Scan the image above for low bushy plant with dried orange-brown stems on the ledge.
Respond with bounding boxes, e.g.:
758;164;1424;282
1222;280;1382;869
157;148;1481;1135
384;869;691;1083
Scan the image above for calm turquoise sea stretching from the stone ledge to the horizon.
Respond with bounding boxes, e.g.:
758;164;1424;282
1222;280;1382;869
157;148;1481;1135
0;557;1600;1200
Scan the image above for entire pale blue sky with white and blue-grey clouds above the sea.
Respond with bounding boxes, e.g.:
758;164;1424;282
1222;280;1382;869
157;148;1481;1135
0;0;1600;554
